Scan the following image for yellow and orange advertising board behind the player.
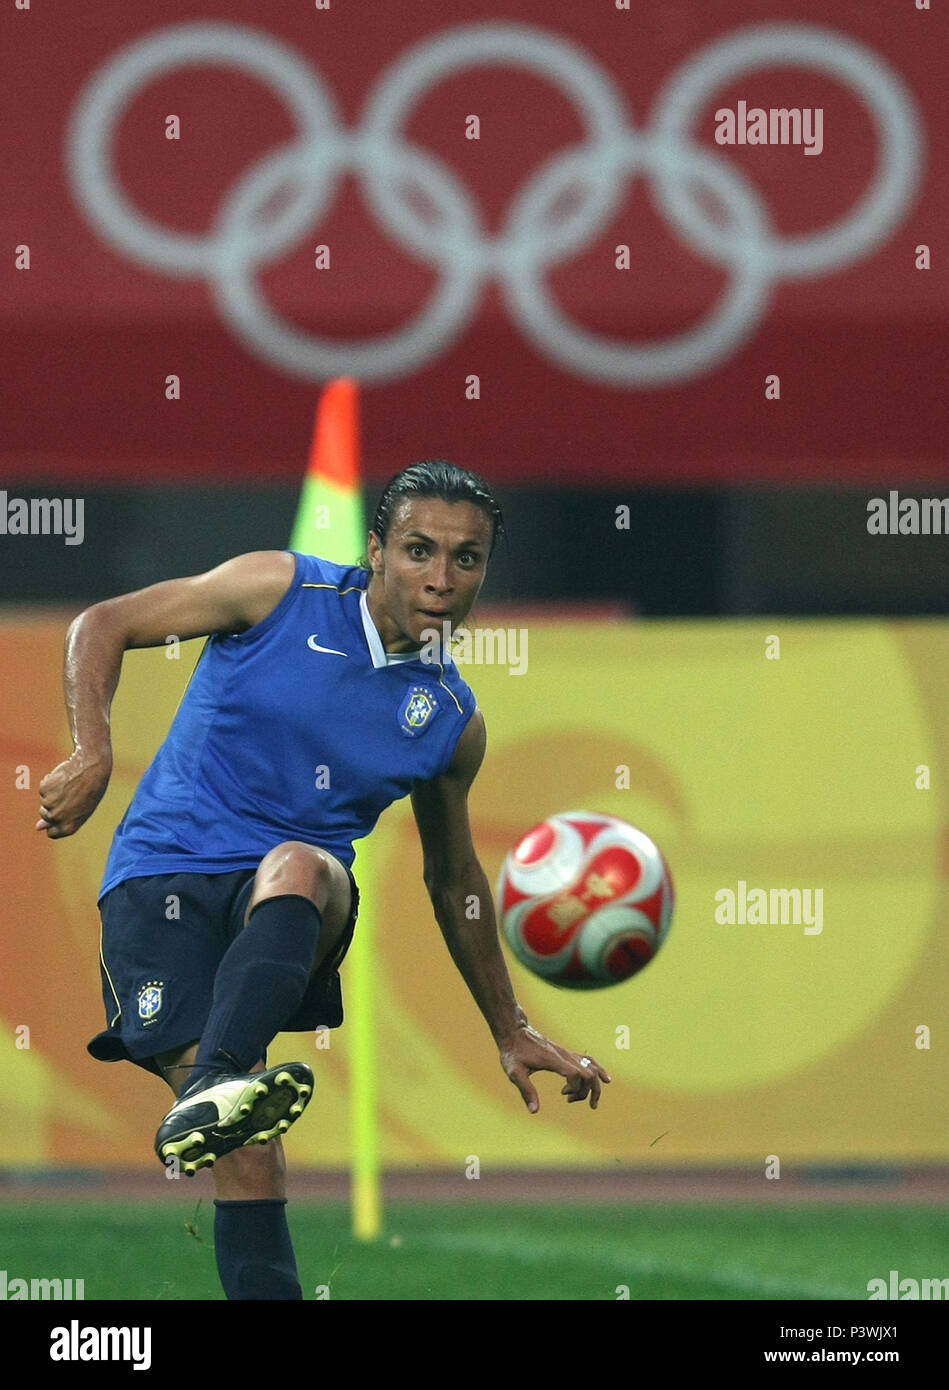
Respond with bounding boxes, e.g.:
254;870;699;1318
0;614;949;1169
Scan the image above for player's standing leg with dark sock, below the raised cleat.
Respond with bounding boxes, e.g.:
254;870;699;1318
156;1043;303;1300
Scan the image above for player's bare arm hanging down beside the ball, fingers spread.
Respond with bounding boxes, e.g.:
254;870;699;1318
411;710;610;1113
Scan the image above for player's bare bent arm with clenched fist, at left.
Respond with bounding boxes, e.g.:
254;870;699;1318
35;550;295;840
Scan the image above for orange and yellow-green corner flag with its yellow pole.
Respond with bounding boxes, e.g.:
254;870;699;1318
290;377;382;1240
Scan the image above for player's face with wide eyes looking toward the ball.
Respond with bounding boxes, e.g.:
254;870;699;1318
367;498;492;652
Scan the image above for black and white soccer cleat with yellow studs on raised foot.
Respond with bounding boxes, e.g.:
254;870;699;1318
154;1062;313;1177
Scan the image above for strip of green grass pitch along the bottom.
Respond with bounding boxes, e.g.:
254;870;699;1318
0;1197;949;1300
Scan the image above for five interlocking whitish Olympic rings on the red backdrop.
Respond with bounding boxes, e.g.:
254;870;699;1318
67;24;923;386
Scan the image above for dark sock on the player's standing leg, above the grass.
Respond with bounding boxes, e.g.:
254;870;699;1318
214;1197;303;1298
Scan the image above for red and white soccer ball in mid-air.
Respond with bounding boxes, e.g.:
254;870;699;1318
496;810;675;990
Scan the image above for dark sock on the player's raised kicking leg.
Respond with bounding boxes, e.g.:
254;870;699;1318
183;892;322;1090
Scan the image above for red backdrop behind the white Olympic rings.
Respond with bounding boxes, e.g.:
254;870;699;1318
0;0;949;488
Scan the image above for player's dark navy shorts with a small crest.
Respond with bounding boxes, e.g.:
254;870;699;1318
89;866;358;1076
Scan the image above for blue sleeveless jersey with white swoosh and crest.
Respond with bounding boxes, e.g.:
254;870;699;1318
99;550;475;898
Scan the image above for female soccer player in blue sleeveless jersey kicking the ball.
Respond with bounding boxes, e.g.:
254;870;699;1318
36;461;610;1298
